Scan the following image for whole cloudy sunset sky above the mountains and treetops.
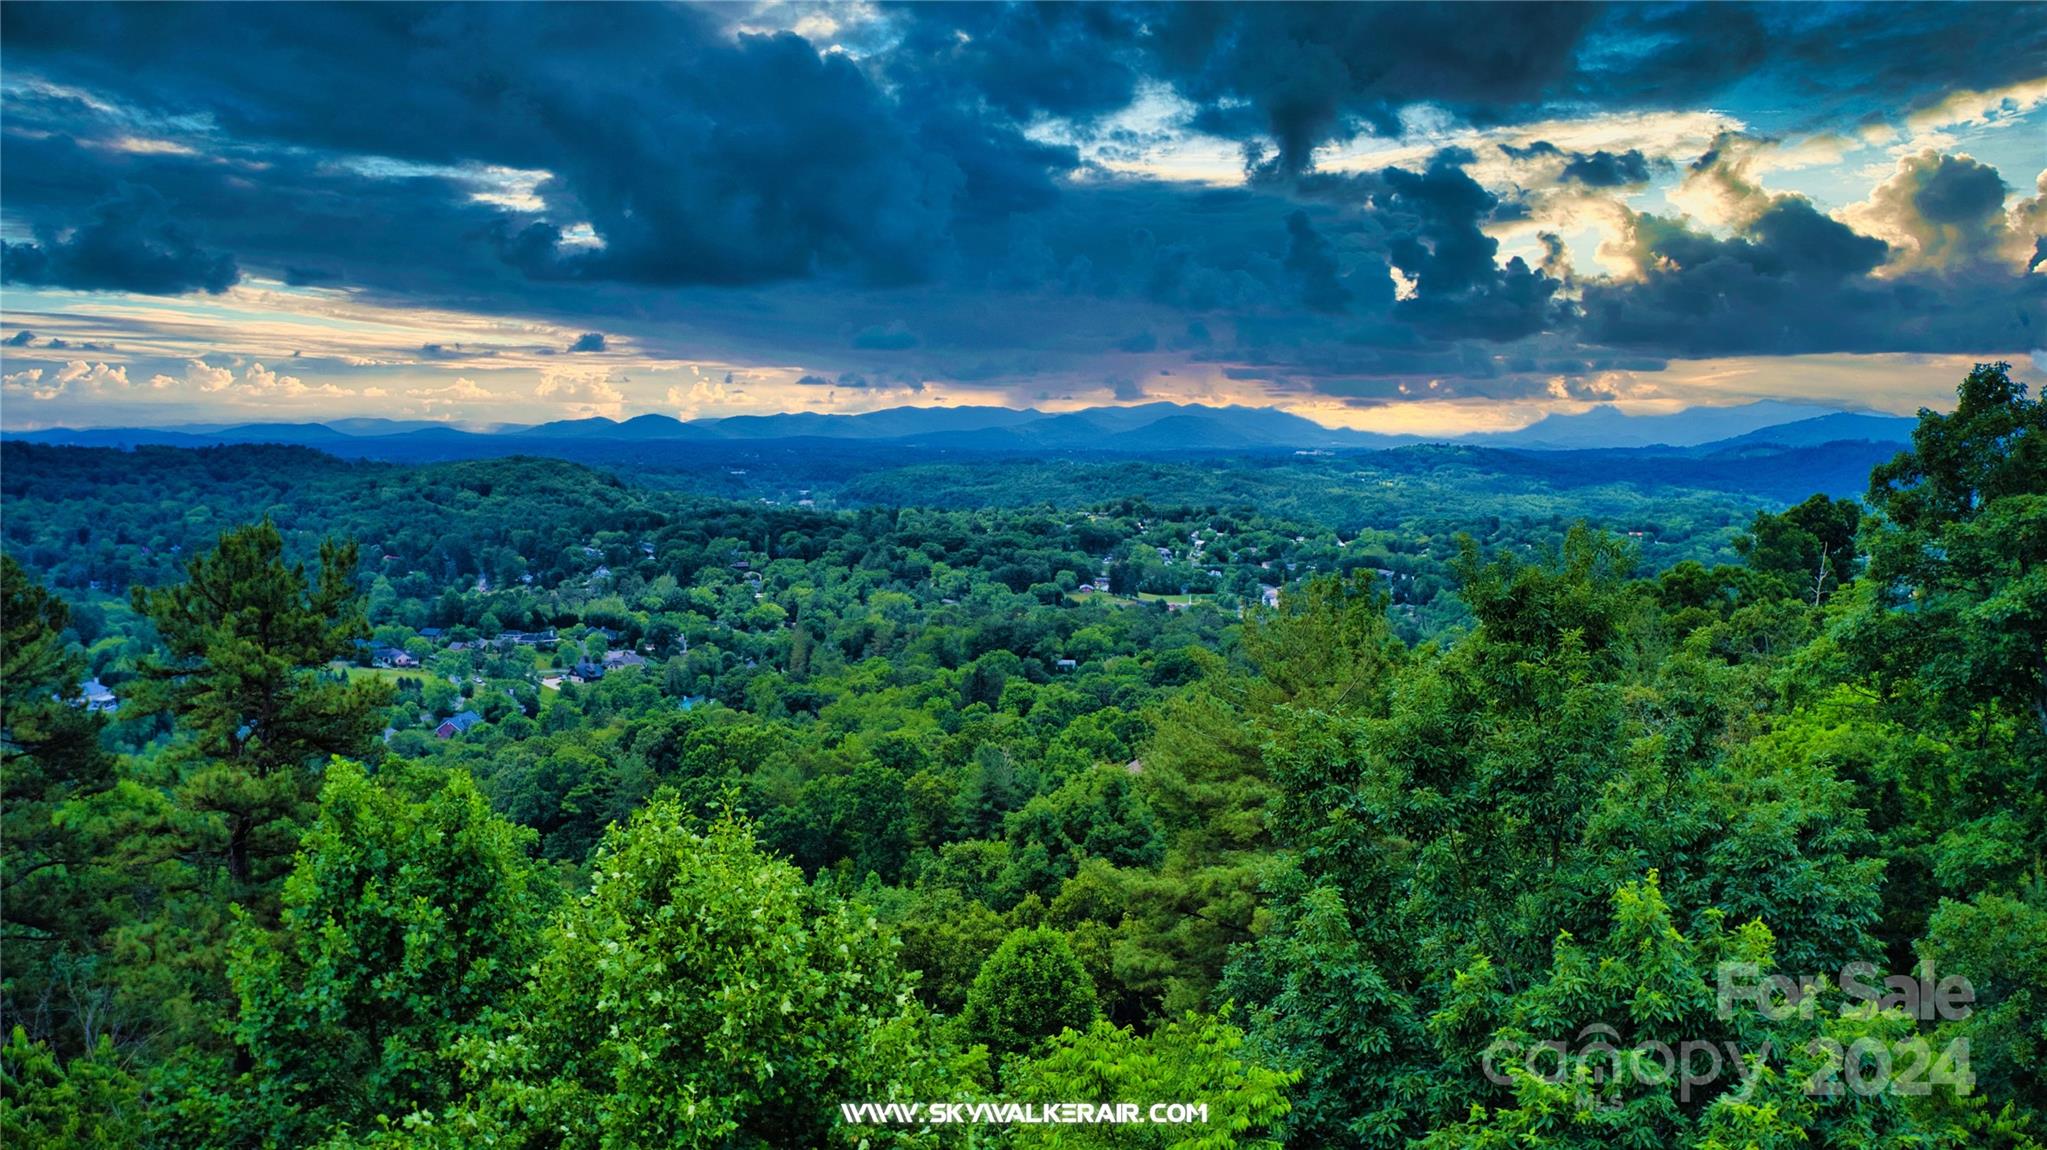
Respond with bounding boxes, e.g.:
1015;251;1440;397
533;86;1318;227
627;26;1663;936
0;2;2047;434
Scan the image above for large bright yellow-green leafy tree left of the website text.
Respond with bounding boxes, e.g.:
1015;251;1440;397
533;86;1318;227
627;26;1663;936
422;796;964;1148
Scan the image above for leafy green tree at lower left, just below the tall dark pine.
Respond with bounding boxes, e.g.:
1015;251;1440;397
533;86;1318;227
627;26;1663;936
227;759;555;1146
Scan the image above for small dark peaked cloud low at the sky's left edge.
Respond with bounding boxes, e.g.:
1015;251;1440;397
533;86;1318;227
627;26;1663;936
0;186;242;295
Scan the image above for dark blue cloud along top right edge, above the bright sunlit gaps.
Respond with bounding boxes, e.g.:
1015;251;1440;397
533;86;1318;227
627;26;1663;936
1072;2;2047;172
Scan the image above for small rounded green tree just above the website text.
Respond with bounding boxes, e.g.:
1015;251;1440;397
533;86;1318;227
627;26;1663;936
960;927;1101;1054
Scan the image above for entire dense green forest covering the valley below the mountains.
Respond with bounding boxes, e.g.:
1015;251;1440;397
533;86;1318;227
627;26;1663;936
0;364;2047;1150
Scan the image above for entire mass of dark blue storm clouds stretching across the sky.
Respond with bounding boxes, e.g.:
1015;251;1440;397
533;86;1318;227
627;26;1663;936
0;4;2047;401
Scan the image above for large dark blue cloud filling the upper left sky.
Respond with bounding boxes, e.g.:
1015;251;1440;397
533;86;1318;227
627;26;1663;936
8;4;1075;284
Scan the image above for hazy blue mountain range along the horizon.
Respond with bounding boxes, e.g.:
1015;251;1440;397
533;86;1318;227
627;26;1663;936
0;401;1914;458
